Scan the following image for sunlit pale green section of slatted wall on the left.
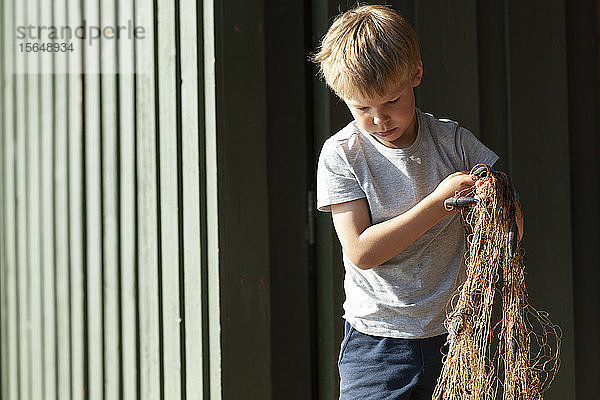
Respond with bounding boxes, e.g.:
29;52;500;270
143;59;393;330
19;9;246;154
0;0;211;399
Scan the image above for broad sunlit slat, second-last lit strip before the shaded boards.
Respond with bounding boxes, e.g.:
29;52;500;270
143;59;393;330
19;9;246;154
176;0;208;399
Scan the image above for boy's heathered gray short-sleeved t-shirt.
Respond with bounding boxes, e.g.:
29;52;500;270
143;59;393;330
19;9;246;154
317;110;498;338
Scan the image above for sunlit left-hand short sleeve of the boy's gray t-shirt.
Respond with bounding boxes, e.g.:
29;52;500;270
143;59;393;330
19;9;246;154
317;140;366;211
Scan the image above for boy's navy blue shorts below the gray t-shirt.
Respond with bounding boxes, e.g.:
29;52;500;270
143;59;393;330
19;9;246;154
338;322;447;400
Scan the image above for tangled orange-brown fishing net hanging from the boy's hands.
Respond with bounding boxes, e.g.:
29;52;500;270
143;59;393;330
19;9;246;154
433;165;561;400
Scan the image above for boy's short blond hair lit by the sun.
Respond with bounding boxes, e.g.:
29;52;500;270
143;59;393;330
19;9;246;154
313;5;421;99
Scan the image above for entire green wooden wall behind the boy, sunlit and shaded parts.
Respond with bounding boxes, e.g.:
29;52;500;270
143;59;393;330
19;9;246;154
0;0;600;400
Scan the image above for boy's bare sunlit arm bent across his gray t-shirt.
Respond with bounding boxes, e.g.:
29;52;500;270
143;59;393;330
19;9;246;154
331;172;474;269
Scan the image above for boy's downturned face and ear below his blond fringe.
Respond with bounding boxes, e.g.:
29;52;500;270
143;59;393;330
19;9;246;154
344;63;423;149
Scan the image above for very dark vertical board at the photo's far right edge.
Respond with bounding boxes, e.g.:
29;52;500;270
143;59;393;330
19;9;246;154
561;1;600;399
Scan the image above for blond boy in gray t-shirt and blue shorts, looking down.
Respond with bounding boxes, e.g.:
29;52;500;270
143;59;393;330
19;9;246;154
315;6;522;399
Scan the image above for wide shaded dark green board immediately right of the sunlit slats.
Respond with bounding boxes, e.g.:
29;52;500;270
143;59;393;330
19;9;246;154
215;1;272;399
